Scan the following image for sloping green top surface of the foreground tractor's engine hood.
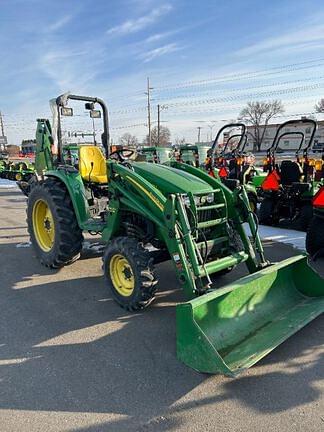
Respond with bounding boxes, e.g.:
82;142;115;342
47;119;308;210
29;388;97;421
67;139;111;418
132;162;213;195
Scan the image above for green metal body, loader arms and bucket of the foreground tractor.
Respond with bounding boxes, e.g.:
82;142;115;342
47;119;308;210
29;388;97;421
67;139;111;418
29;93;324;376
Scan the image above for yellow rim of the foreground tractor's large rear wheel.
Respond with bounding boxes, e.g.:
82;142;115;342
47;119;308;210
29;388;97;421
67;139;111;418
32;199;55;252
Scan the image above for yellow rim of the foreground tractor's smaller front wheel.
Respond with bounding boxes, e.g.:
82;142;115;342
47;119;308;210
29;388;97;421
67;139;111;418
109;254;135;297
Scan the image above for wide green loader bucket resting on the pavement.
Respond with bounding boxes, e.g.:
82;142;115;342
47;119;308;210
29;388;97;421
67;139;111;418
177;255;324;376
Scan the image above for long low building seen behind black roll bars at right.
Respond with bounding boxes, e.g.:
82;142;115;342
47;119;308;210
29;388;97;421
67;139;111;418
245;120;324;152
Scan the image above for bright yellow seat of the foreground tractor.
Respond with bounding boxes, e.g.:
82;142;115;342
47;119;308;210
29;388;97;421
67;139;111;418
79;145;108;184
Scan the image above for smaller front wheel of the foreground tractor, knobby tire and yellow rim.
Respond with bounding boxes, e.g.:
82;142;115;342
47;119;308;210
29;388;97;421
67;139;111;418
103;237;158;311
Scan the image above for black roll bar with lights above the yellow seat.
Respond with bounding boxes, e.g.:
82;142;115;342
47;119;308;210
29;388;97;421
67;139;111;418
56;94;109;162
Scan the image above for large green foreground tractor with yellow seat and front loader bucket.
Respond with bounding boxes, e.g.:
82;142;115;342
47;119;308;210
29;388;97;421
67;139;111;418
27;94;324;376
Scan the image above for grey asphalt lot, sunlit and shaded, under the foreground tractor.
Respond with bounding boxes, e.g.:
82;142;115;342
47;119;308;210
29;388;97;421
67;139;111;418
0;188;324;432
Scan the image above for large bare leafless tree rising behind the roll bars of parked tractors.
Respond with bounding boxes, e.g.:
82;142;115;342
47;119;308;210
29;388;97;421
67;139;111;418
239;100;285;151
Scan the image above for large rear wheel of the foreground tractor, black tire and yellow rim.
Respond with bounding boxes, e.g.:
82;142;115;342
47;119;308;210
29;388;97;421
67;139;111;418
27;178;83;268
